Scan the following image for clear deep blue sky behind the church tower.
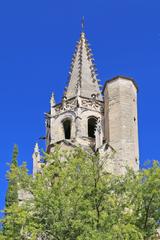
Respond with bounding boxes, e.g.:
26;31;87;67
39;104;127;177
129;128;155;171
0;0;160;214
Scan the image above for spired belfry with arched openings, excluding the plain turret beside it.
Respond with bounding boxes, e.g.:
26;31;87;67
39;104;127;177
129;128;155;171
46;27;104;152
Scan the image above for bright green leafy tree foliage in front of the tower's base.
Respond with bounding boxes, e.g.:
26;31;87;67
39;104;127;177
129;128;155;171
0;148;160;240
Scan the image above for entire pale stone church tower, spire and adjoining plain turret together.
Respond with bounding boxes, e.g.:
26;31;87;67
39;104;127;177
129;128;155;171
33;21;139;174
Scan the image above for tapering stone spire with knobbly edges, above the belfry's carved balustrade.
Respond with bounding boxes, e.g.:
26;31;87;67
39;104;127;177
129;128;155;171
65;20;102;100
